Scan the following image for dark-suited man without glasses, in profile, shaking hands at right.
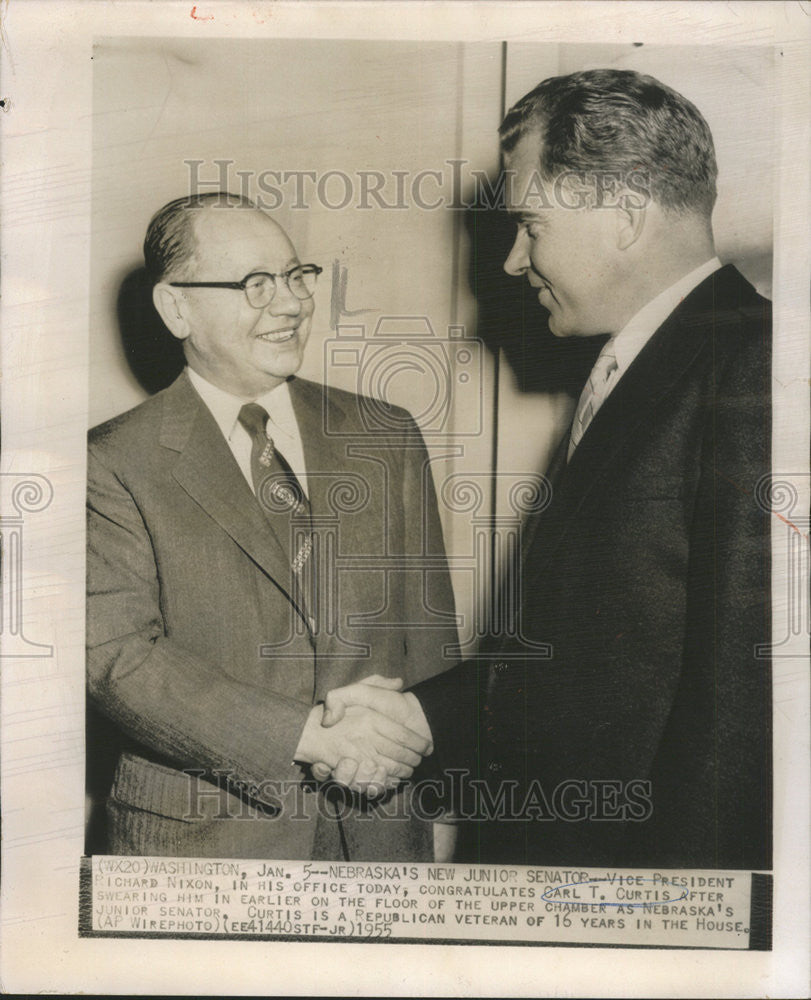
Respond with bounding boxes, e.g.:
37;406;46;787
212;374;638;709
320;70;771;868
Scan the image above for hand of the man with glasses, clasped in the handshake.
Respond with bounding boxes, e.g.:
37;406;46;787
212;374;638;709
295;685;430;794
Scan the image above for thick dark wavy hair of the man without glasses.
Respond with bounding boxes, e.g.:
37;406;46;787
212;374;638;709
499;69;718;216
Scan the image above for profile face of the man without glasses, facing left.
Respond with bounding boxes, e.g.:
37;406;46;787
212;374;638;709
504;133;621;337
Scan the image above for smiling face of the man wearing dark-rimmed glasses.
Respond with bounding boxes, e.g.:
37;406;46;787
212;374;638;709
178;206;314;399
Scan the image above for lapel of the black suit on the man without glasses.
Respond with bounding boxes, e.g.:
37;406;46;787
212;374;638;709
525;268;734;572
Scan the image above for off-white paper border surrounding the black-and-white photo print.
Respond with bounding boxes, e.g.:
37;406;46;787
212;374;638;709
0;0;811;997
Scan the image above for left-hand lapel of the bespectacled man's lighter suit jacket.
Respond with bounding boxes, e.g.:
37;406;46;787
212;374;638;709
160;373;304;600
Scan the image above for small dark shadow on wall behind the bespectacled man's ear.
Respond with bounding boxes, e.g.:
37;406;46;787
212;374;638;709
116;267;186;395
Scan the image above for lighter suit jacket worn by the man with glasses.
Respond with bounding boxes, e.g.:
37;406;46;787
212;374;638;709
87;373;456;860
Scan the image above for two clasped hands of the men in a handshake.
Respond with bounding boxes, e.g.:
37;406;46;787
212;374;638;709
295;674;434;798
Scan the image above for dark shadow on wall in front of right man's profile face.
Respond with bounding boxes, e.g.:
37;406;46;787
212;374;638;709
465;177;608;397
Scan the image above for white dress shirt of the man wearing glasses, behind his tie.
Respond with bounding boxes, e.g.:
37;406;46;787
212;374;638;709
186;368;310;497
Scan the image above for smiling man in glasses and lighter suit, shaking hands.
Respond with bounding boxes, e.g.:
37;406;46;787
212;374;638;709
87;194;464;860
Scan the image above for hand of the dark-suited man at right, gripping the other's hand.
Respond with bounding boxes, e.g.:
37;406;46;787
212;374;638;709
312;674;434;796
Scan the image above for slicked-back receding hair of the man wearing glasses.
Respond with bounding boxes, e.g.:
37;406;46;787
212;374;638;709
144;191;256;284
